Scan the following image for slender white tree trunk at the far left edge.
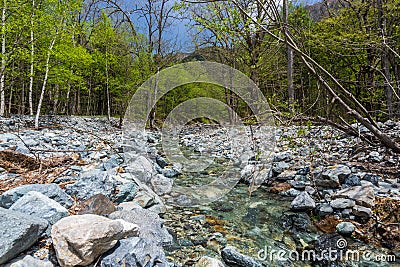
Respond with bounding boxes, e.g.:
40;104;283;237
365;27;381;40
0;0;7;116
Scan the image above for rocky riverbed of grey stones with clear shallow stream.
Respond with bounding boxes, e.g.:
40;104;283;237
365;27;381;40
0;116;400;267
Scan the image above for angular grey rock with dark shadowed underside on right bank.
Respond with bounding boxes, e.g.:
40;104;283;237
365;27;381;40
316;165;351;188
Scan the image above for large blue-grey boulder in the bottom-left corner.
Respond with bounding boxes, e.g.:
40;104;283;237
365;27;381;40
0;208;48;264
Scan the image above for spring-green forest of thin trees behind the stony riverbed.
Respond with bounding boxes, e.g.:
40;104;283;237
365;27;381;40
0;0;400;122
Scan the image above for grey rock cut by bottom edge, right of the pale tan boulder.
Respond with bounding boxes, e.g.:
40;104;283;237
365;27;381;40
100;237;169;267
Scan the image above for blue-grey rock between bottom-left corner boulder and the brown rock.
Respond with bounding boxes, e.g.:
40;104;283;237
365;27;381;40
10;191;69;225
